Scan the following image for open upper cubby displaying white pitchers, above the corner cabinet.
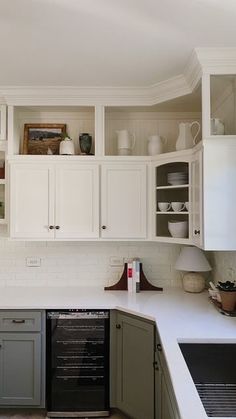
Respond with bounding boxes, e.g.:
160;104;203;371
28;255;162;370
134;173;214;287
104;86;201;156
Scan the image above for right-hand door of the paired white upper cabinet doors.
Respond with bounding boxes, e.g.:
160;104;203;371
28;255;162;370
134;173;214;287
55;164;99;238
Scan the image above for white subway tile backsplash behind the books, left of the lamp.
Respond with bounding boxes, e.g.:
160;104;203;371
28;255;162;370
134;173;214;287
0;238;183;287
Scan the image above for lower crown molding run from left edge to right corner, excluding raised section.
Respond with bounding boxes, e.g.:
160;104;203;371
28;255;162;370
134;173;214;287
0;75;191;106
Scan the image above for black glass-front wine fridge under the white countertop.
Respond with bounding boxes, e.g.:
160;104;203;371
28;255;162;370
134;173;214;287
46;309;109;417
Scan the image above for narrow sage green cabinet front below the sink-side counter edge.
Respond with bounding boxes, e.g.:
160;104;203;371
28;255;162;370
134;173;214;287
155;334;180;419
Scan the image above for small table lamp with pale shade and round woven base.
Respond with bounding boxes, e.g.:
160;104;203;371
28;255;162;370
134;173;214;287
175;246;211;292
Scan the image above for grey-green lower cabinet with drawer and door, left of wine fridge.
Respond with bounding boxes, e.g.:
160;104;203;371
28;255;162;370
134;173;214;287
0;311;45;407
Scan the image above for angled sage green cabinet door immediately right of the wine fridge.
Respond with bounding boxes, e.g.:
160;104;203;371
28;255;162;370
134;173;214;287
116;313;154;419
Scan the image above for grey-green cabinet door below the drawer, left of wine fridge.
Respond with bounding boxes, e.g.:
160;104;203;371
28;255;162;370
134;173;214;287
0;333;41;406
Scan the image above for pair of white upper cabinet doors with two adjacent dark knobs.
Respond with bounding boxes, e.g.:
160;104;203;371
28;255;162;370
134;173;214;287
10;163;99;240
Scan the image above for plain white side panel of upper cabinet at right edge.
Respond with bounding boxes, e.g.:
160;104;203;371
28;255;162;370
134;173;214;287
202;138;236;250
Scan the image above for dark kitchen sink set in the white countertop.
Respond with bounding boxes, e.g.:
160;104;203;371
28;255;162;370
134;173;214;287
179;343;236;417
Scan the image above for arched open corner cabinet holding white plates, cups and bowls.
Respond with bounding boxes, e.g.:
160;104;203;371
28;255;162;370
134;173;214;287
153;151;192;244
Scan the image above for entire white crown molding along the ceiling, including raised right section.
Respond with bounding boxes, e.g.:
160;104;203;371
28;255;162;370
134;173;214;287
0;48;236;106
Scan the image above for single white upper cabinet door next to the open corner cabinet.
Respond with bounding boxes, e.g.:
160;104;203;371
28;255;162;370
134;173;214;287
102;164;147;238
